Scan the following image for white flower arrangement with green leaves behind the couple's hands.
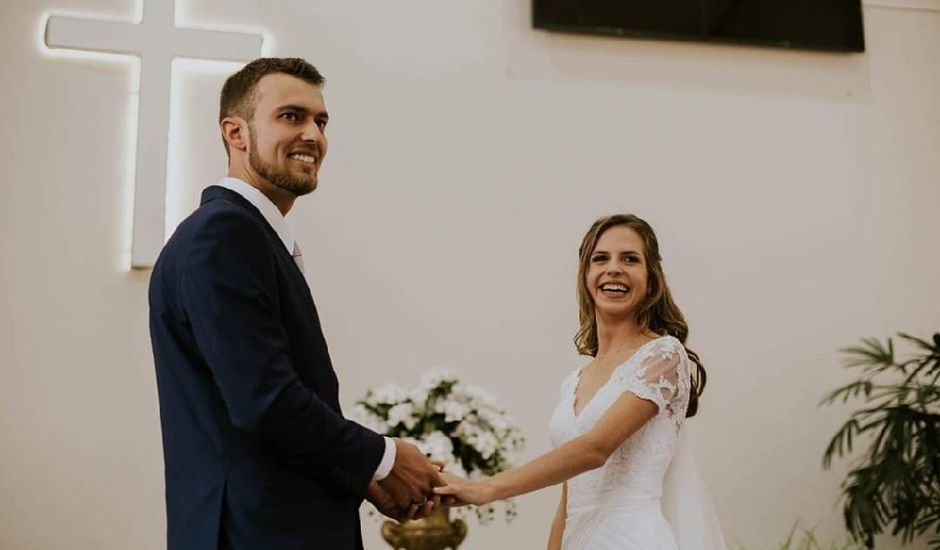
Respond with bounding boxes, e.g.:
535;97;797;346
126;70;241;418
351;371;525;525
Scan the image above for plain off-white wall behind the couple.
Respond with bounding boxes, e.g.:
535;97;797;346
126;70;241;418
0;0;940;550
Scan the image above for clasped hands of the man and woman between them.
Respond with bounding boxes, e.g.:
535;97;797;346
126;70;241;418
366;438;493;521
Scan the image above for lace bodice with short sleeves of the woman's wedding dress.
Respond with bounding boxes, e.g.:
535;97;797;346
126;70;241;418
550;336;691;511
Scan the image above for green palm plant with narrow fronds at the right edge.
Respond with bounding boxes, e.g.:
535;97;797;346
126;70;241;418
822;333;940;550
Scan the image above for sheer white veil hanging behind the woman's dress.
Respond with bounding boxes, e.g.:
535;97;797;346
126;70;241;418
663;422;728;550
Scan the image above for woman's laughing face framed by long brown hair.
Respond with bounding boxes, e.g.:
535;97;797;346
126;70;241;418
584;225;648;317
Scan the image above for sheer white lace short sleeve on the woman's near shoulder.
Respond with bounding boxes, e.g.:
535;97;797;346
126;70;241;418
613;337;684;413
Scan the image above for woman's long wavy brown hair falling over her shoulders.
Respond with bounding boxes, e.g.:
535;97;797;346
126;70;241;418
574;214;707;417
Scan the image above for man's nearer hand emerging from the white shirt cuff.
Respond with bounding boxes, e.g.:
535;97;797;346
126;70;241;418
379;437;444;515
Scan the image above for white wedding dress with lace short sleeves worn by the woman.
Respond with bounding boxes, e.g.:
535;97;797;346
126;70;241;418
550;336;726;550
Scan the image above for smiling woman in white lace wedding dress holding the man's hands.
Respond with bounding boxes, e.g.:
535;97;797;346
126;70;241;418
435;214;725;550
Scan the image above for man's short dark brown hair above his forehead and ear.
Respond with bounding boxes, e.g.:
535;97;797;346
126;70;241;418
219;57;326;152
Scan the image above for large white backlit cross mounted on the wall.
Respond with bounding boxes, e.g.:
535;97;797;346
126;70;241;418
45;0;264;268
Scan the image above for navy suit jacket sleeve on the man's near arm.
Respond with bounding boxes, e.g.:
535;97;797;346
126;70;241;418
180;211;385;495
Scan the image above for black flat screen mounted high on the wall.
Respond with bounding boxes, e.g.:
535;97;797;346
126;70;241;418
532;0;865;52
